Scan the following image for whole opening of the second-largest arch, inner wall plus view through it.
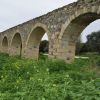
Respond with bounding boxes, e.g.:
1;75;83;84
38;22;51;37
27;27;48;59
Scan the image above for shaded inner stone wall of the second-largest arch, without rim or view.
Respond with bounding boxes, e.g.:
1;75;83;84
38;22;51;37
27;27;46;59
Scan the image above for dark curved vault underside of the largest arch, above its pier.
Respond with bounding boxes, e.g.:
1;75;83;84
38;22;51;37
62;13;100;39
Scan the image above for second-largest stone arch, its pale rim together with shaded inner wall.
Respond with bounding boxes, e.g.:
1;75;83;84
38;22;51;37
26;23;50;59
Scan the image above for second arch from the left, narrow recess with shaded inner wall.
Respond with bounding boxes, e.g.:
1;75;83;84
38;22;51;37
10;33;22;56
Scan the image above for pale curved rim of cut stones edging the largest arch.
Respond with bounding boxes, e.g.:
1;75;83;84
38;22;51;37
59;6;100;39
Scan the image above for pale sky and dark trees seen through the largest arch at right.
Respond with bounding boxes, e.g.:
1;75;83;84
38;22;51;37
75;19;100;57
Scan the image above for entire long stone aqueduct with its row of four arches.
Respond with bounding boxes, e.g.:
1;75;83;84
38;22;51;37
0;0;100;62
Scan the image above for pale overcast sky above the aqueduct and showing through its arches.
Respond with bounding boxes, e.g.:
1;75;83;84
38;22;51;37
0;0;100;41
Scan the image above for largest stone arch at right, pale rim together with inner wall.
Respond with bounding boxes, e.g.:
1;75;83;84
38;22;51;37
59;6;100;62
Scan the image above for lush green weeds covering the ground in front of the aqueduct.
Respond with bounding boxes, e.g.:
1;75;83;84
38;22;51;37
0;54;100;100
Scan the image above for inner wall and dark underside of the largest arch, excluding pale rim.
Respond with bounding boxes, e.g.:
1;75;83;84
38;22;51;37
62;13;100;62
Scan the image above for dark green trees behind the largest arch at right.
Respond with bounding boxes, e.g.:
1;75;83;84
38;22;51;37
76;31;100;54
